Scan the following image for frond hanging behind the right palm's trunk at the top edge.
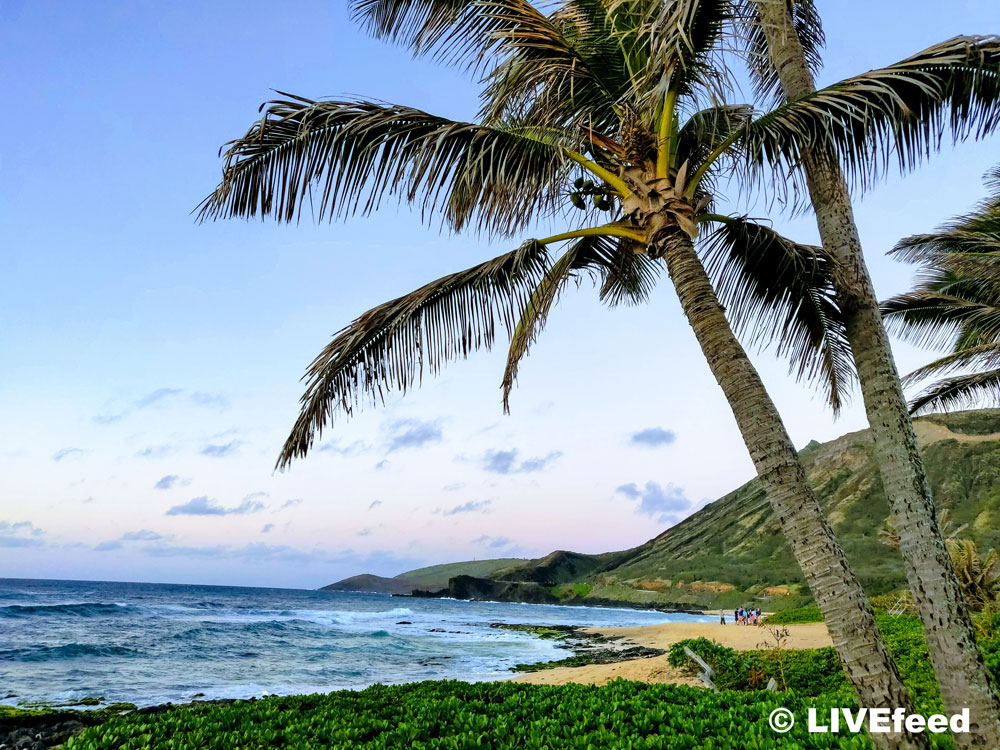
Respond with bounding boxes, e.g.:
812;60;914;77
734;0;826;104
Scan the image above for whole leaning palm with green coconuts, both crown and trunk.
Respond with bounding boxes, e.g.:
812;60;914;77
201;0;926;747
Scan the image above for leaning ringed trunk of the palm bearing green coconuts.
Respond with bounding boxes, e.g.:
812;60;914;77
656;229;929;748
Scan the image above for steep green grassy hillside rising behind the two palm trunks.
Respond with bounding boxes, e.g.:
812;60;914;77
519;409;1000;609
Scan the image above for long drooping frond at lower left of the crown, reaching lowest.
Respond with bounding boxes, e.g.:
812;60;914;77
278;241;549;469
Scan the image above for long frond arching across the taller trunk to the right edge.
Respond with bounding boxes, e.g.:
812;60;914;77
742;36;1000;194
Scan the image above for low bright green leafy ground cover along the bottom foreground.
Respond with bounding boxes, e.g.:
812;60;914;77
64;680;884;750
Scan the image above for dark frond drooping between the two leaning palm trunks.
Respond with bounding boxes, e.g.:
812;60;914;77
705;217;854;412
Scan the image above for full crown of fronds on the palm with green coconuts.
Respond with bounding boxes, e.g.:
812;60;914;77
201;0;1000;466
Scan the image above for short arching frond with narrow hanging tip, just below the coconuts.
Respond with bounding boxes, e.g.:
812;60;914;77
502;236;660;413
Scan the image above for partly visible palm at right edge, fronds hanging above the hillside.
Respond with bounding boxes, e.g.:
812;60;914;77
882;167;1000;414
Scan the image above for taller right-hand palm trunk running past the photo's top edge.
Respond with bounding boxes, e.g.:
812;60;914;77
755;0;1000;750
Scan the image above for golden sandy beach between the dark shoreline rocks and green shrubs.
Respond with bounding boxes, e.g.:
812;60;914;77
514;622;833;685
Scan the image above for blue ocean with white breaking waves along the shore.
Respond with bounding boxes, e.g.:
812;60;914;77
0;579;712;706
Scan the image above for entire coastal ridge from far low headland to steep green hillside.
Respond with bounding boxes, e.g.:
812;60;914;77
323;409;1000;610
